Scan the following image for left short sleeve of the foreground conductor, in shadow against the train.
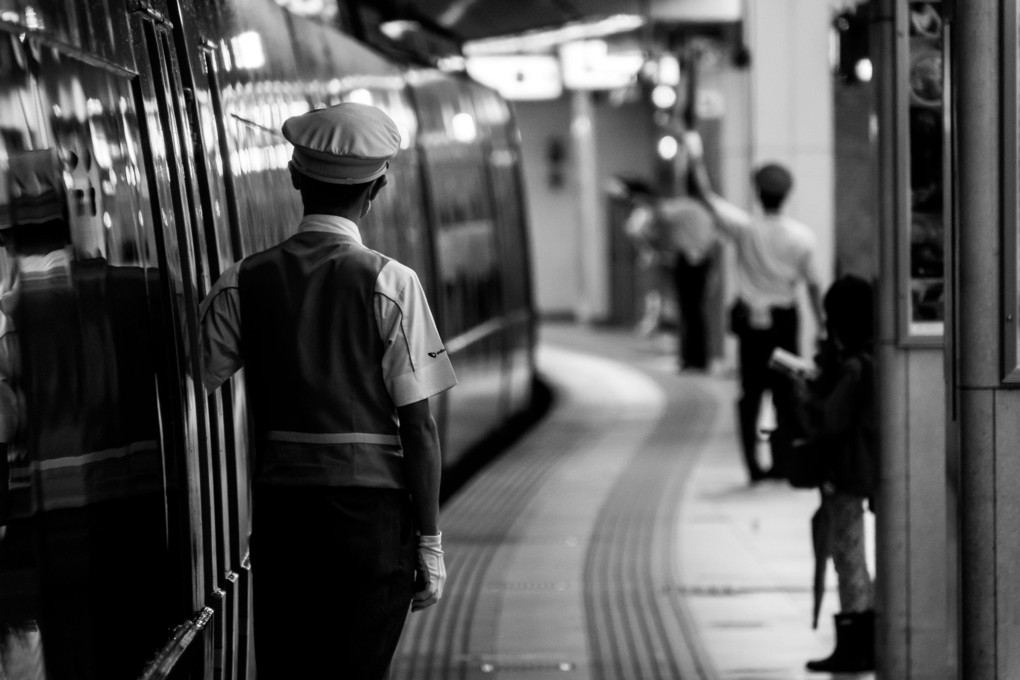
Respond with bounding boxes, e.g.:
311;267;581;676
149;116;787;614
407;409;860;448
199;262;244;391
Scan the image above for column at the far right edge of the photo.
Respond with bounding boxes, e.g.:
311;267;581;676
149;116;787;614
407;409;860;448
952;0;1020;680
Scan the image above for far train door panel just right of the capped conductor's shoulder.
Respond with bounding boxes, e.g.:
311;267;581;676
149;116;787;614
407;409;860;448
407;71;505;467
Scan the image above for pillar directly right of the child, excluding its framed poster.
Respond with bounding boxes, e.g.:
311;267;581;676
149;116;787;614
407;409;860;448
871;0;955;680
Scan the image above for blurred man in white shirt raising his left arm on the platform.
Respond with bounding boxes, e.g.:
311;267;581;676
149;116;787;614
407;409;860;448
685;133;825;483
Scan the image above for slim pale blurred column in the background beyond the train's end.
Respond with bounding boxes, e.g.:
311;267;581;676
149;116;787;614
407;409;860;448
570;91;609;322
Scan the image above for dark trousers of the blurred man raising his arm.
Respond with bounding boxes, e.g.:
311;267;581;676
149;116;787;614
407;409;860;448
736;307;798;480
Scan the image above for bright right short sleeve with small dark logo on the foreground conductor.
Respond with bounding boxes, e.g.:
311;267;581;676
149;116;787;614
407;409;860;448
375;261;457;406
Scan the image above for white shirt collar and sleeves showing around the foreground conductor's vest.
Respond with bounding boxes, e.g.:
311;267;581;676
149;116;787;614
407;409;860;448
201;215;457;407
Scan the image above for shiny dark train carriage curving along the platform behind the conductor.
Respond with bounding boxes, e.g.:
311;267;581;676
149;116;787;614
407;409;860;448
0;0;534;679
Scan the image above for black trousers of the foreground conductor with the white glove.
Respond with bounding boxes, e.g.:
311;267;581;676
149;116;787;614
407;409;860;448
252;486;417;680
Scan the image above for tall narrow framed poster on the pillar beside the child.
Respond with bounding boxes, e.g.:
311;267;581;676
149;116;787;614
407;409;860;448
900;1;949;343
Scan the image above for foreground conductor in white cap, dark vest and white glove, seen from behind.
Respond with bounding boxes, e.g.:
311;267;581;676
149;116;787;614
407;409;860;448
202;98;457;680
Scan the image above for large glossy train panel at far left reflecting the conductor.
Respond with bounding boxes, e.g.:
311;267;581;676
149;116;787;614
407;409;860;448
0;33;173;677
